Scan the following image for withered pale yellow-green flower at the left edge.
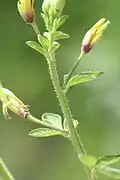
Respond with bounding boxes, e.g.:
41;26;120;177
0;85;30;119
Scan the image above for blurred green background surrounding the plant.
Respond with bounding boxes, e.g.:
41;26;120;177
0;0;120;180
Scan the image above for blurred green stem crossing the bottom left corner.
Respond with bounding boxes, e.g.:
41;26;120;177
0;158;14;180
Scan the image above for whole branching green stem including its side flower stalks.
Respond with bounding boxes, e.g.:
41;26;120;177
31;17;86;174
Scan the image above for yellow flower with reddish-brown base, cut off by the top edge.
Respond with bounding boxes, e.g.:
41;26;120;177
17;0;35;23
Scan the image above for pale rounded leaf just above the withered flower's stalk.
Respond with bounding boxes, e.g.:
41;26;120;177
42;113;63;129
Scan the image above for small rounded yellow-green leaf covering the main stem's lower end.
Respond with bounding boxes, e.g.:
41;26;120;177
79;154;97;167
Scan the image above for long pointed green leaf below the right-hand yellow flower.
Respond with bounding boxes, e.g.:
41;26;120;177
66;71;103;89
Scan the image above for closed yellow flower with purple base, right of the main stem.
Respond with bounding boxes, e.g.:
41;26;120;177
81;18;110;53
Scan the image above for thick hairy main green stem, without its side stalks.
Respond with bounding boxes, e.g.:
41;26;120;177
46;53;85;156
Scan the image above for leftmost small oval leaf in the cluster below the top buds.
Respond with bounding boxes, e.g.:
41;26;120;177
26;41;44;54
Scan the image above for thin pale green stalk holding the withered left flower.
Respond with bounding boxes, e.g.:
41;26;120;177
27;114;68;134
